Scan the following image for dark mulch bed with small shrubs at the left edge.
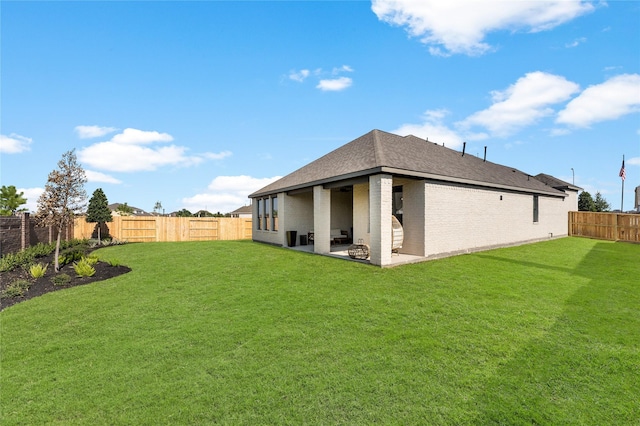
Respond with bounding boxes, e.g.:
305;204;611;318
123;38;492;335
0;250;131;311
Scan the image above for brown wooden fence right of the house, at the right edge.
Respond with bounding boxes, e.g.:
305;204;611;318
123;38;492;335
569;212;640;243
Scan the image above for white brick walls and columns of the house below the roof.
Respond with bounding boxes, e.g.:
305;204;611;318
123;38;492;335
253;175;578;266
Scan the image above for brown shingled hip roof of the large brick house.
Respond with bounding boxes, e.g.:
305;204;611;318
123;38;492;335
249;130;566;198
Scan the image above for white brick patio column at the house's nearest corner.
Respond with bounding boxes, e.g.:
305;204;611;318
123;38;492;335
369;174;393;266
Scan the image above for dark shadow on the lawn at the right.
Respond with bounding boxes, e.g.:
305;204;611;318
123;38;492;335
472;242;640;425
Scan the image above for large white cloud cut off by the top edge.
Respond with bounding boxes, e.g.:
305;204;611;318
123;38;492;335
371;0;595;55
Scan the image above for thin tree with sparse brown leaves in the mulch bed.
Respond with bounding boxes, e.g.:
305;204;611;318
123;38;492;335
36;150;87;272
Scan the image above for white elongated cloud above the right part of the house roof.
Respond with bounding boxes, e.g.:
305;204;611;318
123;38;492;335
459;71;579;137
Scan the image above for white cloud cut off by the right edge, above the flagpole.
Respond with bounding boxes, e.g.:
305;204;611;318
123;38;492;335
556;74;640;127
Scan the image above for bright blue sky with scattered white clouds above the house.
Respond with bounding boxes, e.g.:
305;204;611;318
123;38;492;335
0;0;640;213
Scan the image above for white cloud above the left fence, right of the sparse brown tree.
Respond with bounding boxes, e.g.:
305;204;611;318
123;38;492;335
78;129;231;172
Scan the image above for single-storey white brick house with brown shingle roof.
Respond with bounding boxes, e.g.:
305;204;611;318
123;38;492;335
249;130;580;266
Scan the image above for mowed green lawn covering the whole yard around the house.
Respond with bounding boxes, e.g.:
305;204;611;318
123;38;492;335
0;238;640;425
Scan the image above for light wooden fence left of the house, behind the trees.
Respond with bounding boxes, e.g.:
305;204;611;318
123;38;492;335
73;216;252;242
